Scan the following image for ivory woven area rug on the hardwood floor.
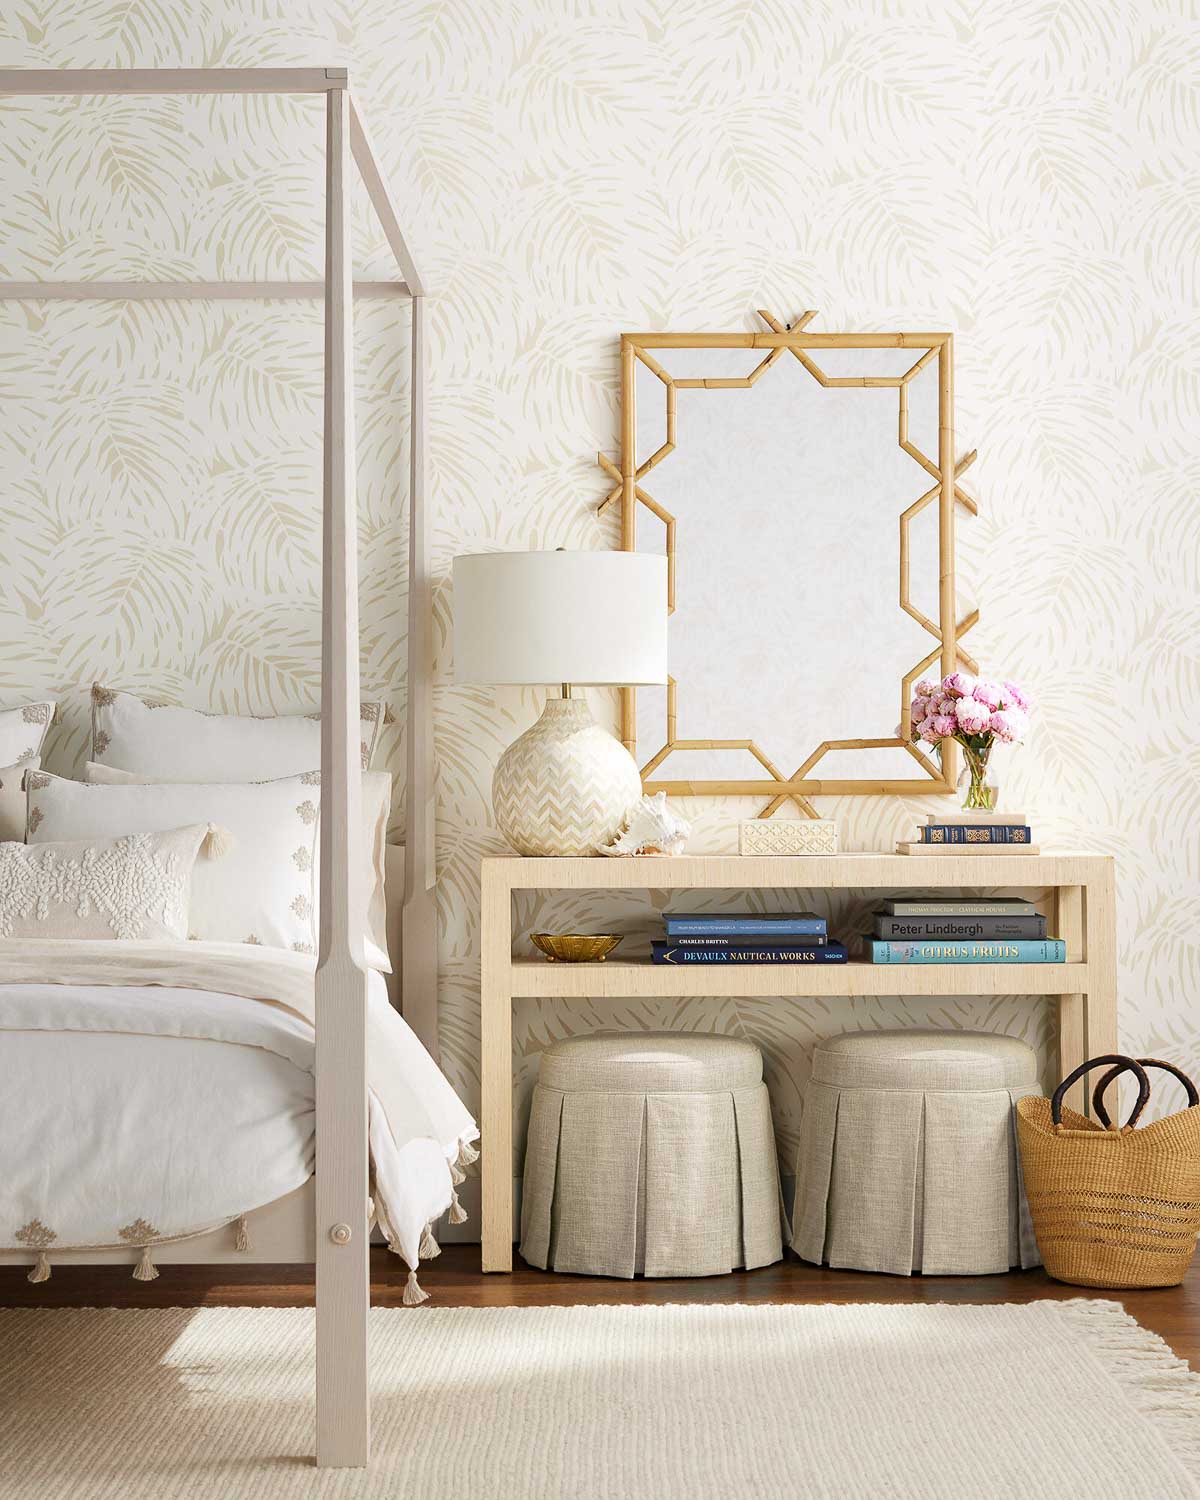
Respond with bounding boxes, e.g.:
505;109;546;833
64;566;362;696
0;1301;1200;1500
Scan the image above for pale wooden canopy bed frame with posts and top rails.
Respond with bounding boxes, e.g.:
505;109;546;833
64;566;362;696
0;68;437;1467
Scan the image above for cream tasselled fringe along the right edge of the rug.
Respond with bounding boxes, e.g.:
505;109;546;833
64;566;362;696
1058;1298;1200;1479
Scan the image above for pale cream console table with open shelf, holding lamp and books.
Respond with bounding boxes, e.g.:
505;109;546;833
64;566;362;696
480;854;1118;1271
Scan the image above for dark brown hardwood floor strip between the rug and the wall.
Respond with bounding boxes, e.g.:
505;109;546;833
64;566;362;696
0;1245;1200;1368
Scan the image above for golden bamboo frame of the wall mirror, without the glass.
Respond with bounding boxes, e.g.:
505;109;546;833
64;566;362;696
597;311;980;818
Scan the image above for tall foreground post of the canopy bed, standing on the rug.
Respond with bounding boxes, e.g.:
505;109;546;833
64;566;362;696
317;79;371;1467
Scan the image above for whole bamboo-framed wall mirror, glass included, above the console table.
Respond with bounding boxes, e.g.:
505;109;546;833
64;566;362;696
600;312;978;818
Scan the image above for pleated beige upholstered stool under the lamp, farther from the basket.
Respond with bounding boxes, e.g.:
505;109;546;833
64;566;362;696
521;1032;783;1277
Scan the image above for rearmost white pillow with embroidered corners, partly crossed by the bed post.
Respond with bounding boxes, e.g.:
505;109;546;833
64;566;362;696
93;684;384;785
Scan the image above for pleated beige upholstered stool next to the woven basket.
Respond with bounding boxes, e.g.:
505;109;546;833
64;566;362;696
792;1031;1041;1277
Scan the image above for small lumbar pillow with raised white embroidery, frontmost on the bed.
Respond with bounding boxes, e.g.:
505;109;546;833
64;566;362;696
0;824;209;941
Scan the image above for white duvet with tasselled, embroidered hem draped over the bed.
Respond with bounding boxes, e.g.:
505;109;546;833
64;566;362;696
0;941;479;1269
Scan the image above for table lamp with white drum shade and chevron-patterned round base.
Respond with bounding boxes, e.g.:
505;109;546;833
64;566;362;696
453;552;668;855
